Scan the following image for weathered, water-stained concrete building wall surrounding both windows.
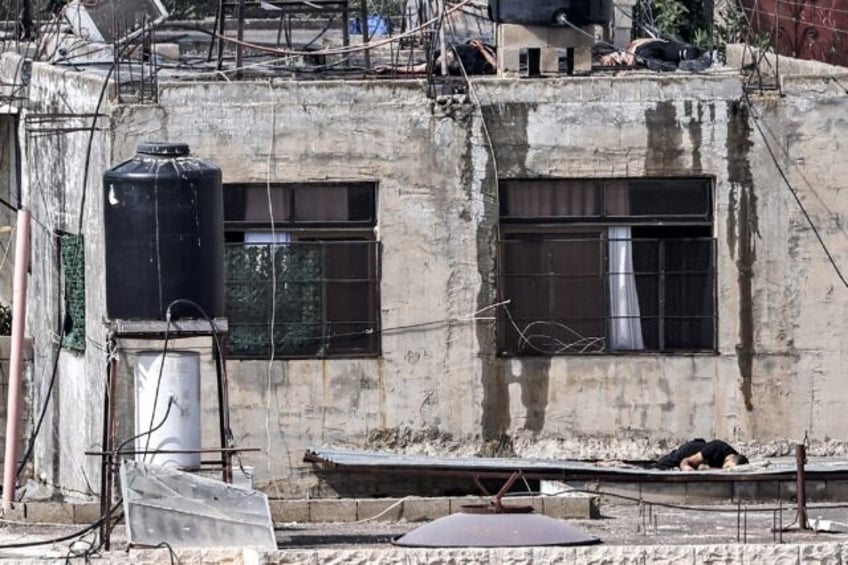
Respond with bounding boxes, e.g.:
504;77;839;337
9;51;848;496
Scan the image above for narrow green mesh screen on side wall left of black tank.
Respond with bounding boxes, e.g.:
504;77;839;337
59;234;85;351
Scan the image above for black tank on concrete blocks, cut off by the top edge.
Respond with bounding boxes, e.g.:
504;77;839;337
489;0;611;26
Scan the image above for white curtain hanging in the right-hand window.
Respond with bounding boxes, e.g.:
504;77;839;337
609;226;645;350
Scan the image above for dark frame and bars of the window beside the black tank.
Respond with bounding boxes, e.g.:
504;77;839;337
224;182;382;360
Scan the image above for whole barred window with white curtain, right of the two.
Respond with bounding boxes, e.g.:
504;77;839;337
498;178;716;355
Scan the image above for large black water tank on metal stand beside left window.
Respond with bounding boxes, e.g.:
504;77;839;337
103;143;224;320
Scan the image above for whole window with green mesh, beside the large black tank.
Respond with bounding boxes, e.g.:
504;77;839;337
224;183;380;358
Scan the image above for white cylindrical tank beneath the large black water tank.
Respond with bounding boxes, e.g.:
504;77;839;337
135;351;201;471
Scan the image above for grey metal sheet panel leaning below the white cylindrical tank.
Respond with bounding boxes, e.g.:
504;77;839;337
121;459;277;549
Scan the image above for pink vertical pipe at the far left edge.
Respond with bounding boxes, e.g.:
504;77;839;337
3;209;29;509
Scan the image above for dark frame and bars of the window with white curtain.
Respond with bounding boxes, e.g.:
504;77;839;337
497;177;719;357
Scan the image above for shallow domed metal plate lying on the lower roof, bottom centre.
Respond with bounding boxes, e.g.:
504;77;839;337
394;513;601;547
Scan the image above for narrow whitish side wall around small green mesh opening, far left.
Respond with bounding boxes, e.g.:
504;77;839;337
6;54;111;492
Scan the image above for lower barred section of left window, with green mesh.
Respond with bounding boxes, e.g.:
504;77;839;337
225;241;379;358
